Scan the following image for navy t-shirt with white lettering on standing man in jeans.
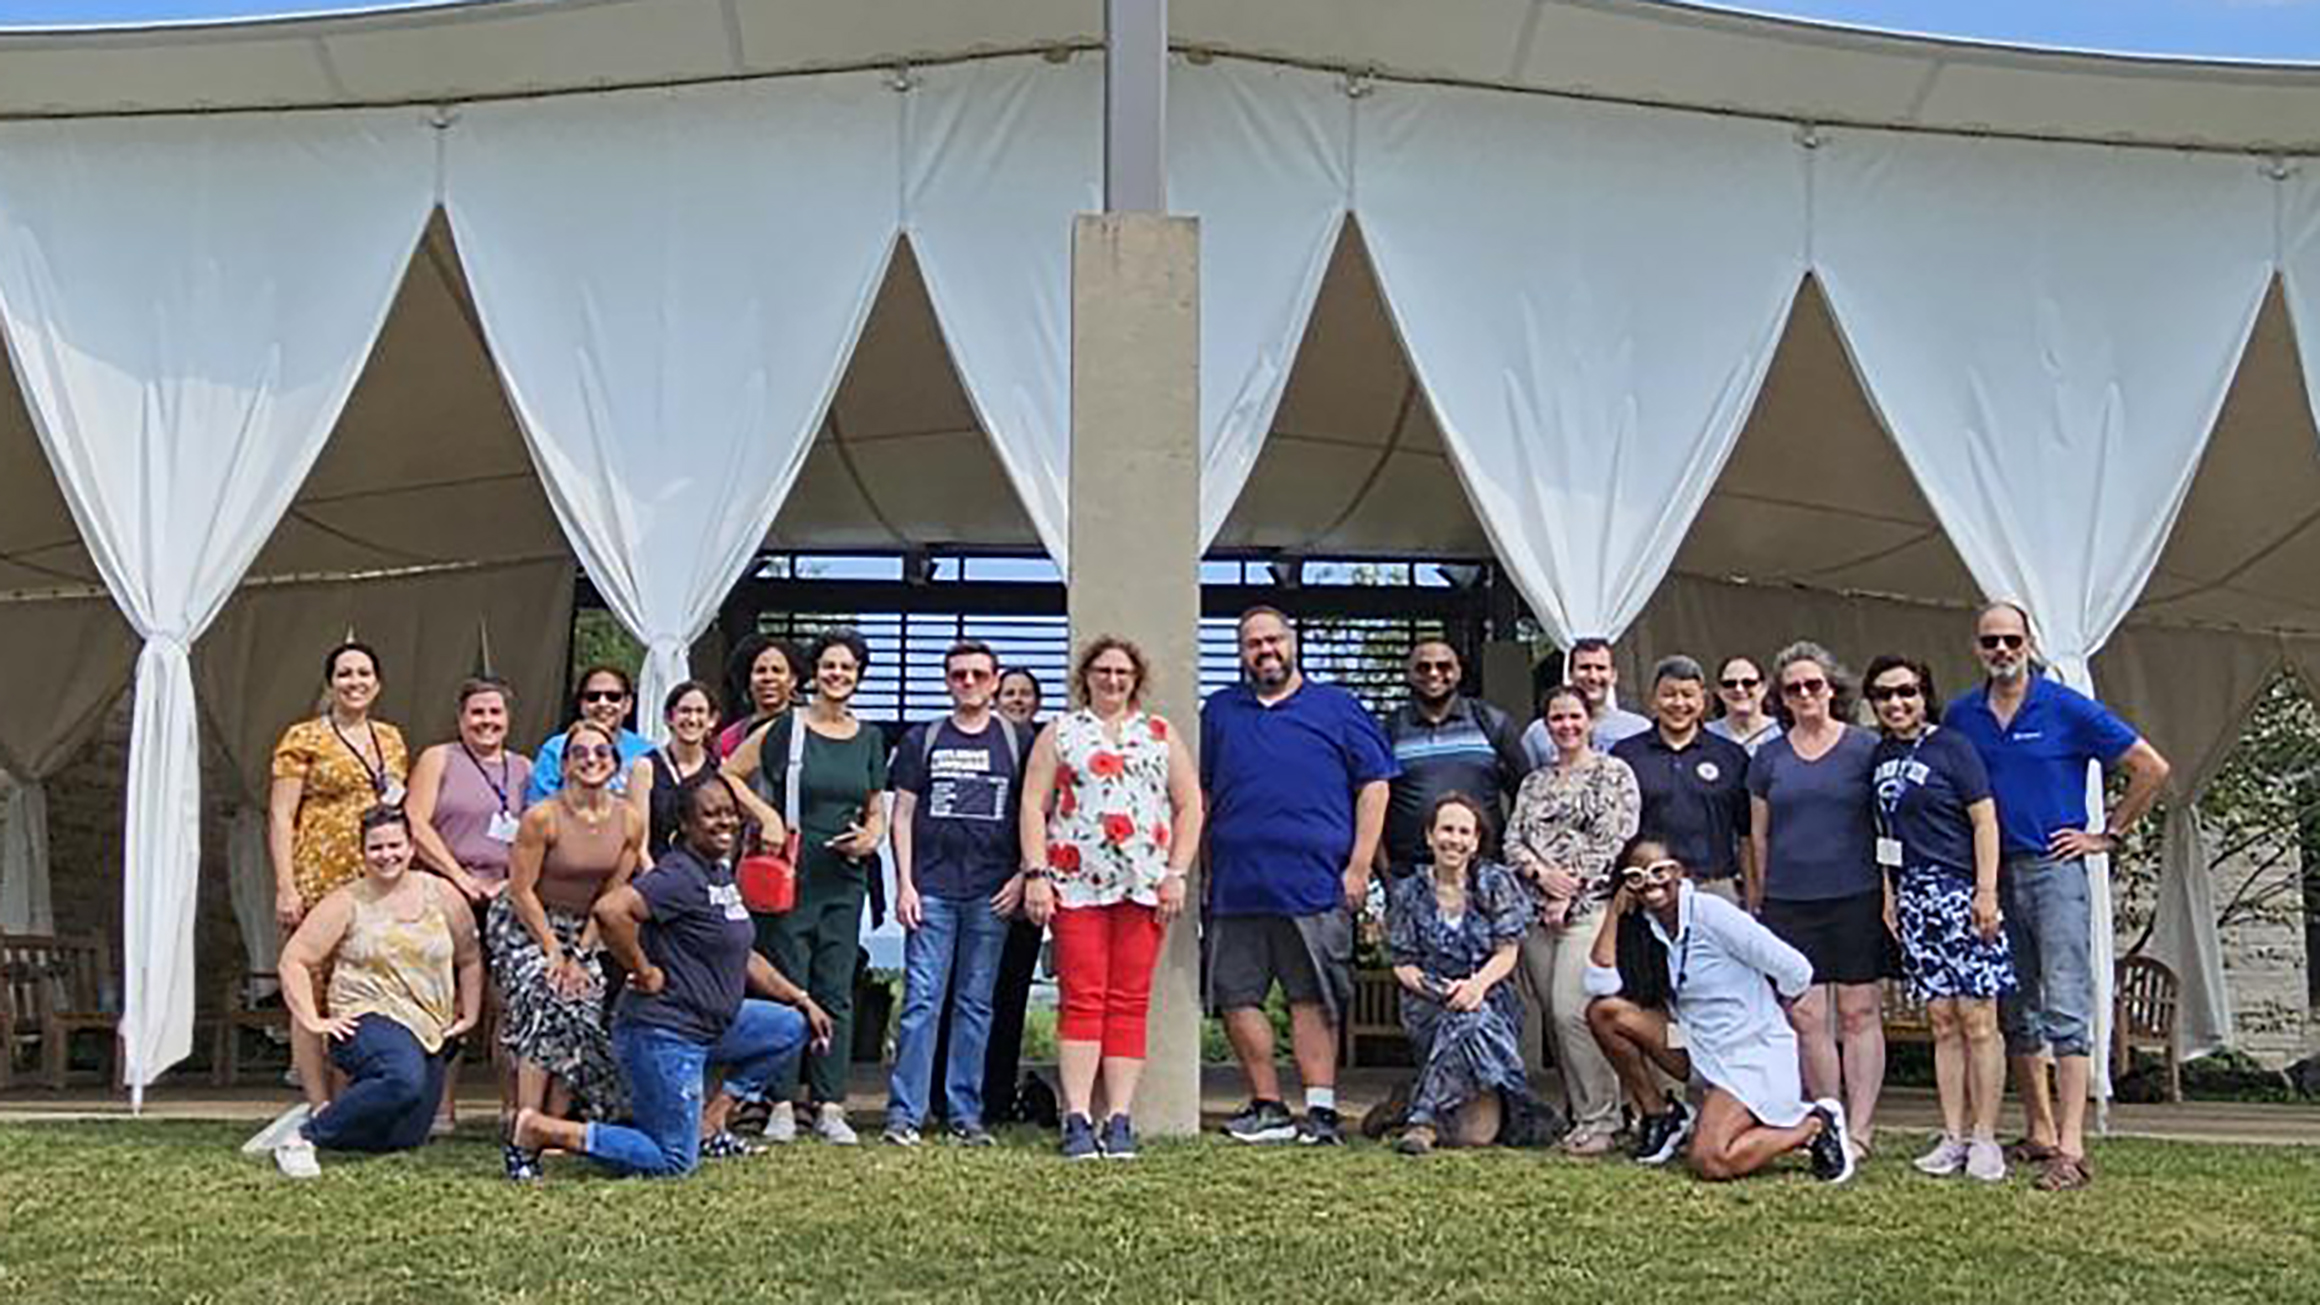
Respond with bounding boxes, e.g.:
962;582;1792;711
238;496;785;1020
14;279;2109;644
886;715;1030;896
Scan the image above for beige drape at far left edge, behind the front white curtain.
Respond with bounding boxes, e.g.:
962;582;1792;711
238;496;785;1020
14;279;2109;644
0;597;137;933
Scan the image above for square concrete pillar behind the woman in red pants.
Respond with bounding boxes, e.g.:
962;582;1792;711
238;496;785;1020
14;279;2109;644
1067;214;1199;1135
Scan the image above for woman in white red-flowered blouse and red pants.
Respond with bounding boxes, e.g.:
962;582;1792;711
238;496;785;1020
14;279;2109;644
1023;634;1202;1159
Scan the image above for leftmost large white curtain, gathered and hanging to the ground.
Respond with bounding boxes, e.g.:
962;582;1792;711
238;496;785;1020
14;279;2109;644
0;111;434;1105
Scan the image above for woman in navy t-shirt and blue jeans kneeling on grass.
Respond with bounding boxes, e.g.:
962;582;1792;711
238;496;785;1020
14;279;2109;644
515;771;831;1177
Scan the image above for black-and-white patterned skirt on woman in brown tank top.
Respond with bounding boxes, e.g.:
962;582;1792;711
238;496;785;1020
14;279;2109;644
487;894;629;1119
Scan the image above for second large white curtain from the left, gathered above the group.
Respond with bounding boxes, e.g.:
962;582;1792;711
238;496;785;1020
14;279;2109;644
445;74;900;738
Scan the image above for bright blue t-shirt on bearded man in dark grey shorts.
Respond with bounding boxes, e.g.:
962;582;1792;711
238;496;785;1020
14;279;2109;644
1199;680;1401;915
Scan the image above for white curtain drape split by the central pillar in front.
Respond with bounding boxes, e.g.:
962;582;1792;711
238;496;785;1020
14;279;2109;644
902;58;1353;562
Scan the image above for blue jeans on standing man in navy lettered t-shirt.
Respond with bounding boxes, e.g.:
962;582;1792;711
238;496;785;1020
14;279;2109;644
886;894;1007;1129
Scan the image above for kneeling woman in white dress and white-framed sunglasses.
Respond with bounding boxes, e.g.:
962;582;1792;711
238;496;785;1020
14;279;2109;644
1587;836;1854;1182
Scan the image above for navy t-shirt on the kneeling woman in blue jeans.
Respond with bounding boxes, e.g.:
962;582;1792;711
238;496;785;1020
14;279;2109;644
617;843;756;1043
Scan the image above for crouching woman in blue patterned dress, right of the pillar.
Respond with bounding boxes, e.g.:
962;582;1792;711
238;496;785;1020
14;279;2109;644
1385;792;1534;1156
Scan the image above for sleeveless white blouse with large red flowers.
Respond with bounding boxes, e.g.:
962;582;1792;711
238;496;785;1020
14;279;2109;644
1046;708;1169;910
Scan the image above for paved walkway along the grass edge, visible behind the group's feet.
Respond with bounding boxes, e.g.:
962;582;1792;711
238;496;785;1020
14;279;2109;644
0;1066;2320;1147
